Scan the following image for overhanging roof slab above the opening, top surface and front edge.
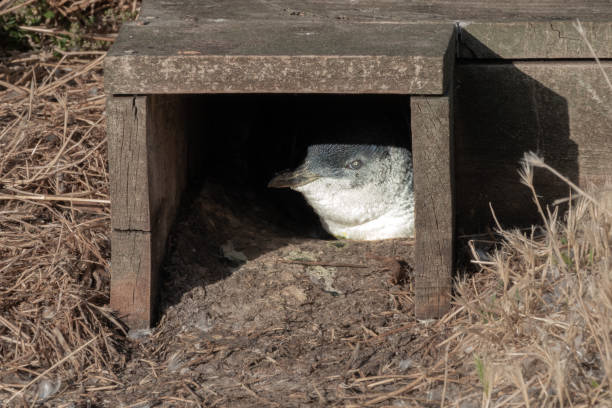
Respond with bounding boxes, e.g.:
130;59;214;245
105;21;454;94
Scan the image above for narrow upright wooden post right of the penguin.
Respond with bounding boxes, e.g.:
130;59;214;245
410;96;454;319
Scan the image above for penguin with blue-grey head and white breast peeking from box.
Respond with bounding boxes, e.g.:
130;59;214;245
269;143;414;240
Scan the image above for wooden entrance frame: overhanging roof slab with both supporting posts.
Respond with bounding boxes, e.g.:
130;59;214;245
105;0;455;327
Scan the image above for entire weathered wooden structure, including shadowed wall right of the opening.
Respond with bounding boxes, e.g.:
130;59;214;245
105;0;612;328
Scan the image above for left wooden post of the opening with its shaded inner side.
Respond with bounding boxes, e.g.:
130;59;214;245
107;95;187;328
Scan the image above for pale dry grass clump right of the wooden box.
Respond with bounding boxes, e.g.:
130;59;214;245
457;161;612;407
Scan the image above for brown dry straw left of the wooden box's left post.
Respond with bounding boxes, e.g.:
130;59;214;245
0;48;122;402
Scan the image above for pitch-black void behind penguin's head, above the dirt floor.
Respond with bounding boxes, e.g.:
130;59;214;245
187;94;410;237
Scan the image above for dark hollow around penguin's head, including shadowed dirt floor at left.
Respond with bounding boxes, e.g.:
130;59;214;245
162;94;411;304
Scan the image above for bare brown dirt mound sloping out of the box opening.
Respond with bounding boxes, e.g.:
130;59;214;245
52;184;467;407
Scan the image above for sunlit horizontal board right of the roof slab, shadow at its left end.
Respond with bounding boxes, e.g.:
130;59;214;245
458;20;612;59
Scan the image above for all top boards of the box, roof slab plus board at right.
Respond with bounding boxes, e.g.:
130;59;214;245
105;0;612;95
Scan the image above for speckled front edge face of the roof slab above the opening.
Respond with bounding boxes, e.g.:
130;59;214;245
105;56;444;94
